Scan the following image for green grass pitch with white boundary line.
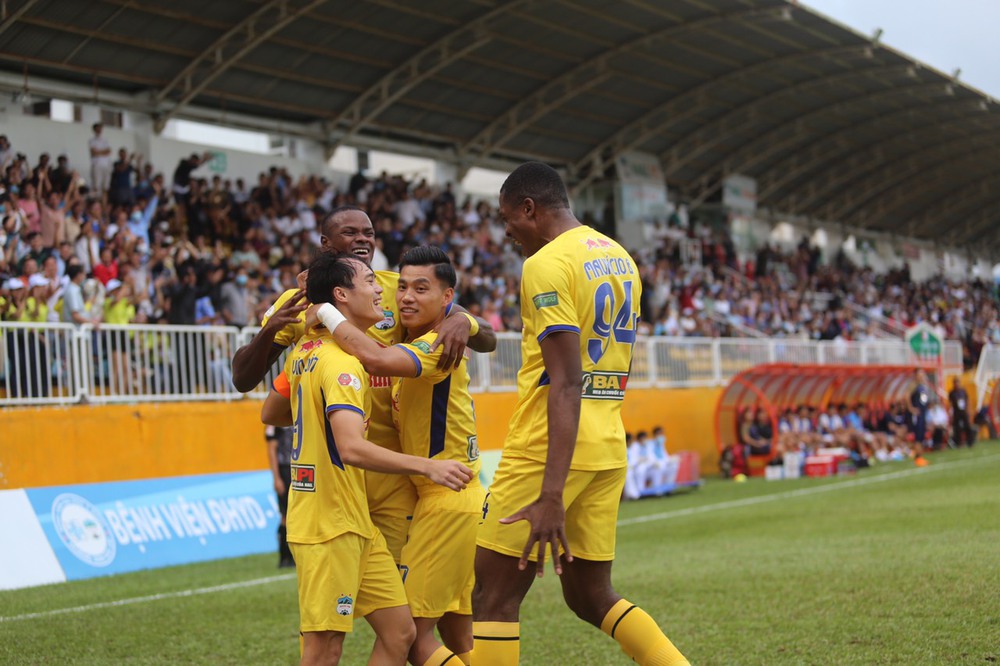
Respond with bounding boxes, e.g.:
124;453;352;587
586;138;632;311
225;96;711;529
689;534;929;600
0;443;1000;666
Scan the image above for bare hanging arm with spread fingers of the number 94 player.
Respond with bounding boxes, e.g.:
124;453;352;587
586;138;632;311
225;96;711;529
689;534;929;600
500;331;583;578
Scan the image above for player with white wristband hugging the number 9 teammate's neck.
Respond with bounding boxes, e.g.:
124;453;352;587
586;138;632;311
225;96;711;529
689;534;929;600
314;246;484;666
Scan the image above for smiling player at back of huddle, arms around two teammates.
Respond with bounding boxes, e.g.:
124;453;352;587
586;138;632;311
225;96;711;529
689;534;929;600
233;206;496;564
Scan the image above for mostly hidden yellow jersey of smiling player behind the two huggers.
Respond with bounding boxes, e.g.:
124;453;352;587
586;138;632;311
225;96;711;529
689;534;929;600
261;271;404;451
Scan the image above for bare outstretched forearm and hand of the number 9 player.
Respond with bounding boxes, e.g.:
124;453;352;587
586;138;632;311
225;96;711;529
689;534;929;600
327;408;472;491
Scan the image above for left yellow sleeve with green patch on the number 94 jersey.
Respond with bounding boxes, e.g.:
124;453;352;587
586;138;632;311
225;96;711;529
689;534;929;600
521;255;580;342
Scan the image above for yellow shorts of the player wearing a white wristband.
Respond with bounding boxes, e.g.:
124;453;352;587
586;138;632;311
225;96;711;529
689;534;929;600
399;481;486;617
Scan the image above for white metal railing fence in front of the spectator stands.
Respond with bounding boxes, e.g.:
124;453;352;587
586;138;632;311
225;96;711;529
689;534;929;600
0;322;962;406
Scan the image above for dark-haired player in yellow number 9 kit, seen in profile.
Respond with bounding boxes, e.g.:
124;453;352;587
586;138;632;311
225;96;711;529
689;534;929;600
285;254;473;664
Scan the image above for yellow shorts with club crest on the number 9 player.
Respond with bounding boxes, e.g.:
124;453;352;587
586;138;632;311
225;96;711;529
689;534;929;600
288;532;406;632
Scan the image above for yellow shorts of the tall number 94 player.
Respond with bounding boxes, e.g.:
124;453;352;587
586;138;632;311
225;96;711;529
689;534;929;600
476;455;627;562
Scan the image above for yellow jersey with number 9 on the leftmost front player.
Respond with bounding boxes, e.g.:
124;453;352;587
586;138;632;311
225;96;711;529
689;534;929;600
285;332;375;543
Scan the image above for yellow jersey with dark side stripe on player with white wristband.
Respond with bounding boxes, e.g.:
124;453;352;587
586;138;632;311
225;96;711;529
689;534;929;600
392;331;479;491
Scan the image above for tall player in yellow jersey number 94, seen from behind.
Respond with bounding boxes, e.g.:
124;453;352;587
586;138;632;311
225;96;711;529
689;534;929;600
472;162;688;666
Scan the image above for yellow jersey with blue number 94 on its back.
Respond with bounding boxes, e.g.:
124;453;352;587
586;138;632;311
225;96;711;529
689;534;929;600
504;226;642;470
